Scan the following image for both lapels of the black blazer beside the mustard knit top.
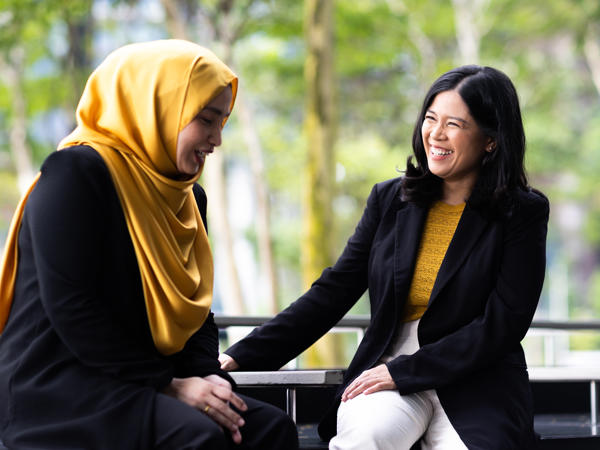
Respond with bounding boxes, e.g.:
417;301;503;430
394;203;488;310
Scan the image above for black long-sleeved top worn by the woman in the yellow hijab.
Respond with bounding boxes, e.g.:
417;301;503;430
0;146;233;450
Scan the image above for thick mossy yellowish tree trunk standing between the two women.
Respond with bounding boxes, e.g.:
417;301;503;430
302;0;346;367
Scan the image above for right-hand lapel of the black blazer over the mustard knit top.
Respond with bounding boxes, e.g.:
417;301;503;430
429;206;488;305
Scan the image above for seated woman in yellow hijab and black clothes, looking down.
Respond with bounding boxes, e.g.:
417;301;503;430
0;40;297;450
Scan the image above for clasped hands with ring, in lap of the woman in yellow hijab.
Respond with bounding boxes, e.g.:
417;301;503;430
163;375;248;444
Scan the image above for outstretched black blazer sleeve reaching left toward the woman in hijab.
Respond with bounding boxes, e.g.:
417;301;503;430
225;181;392;370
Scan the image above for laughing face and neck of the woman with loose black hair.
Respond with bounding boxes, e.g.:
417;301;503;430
421;90;493;201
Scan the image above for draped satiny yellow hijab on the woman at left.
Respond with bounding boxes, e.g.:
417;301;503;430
0;40;237;355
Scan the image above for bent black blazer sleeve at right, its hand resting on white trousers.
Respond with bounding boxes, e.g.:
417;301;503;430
387;194;549;394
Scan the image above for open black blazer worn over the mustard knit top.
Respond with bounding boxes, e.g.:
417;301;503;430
226;178;549;450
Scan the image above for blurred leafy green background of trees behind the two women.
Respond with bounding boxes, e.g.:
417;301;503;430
0;0;600;364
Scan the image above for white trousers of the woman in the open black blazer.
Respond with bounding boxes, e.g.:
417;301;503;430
329;320;467;450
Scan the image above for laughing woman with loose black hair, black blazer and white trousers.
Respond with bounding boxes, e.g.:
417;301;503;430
220;66;549;450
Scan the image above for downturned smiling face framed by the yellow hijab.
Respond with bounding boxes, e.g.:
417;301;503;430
176;86;233;179
